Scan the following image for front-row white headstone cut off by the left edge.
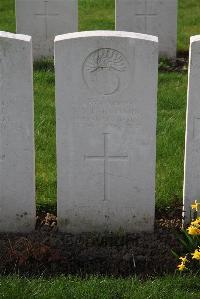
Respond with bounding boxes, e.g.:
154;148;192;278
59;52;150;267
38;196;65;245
0;32;35;232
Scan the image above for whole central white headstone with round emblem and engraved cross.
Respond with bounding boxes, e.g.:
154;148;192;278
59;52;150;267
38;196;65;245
55;31;158;233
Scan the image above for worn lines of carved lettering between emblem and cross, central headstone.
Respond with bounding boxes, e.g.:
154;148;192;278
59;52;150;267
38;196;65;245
73;100;135;127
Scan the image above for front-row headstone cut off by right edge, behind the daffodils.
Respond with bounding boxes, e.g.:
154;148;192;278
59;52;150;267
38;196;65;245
183;35;200;224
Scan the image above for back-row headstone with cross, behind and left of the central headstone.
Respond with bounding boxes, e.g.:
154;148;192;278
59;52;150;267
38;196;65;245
16;0;78;59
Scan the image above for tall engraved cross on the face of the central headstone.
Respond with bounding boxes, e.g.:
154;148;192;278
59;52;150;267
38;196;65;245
84;133;128;201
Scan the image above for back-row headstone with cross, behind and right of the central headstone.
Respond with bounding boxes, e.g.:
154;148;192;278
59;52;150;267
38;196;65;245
116;0;177;58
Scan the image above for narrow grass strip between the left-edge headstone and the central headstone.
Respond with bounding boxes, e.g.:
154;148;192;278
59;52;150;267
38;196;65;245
34;61;56;211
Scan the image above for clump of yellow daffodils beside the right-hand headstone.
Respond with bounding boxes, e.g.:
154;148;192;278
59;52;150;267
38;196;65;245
177;201;200;272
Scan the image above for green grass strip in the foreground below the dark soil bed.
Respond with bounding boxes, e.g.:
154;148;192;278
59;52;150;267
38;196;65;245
0;276;200;299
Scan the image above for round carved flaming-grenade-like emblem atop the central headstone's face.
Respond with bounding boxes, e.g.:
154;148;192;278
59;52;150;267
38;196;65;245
83;48;129;95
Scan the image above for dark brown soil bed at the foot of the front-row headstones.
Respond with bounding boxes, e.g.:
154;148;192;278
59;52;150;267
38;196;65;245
0;207;182;277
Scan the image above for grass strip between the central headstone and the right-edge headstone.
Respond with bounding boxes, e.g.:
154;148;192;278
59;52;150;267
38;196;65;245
156;73;187;207
